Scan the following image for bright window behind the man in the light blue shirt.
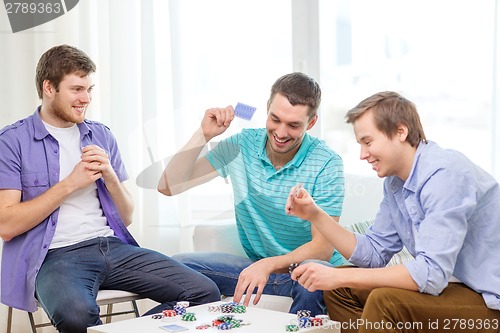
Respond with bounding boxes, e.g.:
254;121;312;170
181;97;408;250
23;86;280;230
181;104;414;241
319;0;498;176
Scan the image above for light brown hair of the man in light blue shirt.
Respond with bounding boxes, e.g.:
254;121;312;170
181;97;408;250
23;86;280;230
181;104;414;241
345;91;427;147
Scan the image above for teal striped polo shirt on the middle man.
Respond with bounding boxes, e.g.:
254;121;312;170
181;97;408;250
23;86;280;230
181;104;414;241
205;128;344;265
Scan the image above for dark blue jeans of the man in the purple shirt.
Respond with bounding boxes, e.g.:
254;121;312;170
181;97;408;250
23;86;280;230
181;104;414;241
35;237;220;333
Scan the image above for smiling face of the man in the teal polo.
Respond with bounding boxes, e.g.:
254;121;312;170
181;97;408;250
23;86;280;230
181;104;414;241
266;94;318;167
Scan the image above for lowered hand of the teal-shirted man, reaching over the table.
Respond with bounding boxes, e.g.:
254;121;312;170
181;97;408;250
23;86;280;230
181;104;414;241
233;259;272;306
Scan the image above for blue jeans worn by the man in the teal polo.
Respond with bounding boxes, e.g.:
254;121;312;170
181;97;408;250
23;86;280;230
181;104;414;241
172;252;326;316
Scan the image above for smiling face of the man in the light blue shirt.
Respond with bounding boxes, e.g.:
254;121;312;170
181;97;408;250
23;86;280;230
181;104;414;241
353;110;416;180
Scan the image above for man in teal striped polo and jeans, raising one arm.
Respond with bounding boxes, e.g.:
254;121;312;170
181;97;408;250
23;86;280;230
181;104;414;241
158;72;344;315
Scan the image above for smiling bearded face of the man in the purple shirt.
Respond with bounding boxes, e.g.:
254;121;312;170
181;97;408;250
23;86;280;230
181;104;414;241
40;73;93;127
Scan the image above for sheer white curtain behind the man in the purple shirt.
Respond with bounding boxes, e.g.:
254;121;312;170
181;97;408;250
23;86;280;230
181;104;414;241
0;0;177;249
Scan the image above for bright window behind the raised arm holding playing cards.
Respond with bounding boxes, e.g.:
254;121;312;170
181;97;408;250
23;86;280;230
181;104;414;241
156;0;292;226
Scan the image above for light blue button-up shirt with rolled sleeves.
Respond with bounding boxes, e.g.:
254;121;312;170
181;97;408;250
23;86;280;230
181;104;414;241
349;142;500;309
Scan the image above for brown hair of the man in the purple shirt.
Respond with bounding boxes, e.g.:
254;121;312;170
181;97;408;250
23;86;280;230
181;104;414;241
36;45;96;99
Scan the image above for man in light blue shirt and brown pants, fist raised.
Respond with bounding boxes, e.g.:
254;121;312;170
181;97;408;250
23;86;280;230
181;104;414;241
286;92;500;332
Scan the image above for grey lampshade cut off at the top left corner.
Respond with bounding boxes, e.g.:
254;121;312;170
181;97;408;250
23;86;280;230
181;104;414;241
3;0;79;33
